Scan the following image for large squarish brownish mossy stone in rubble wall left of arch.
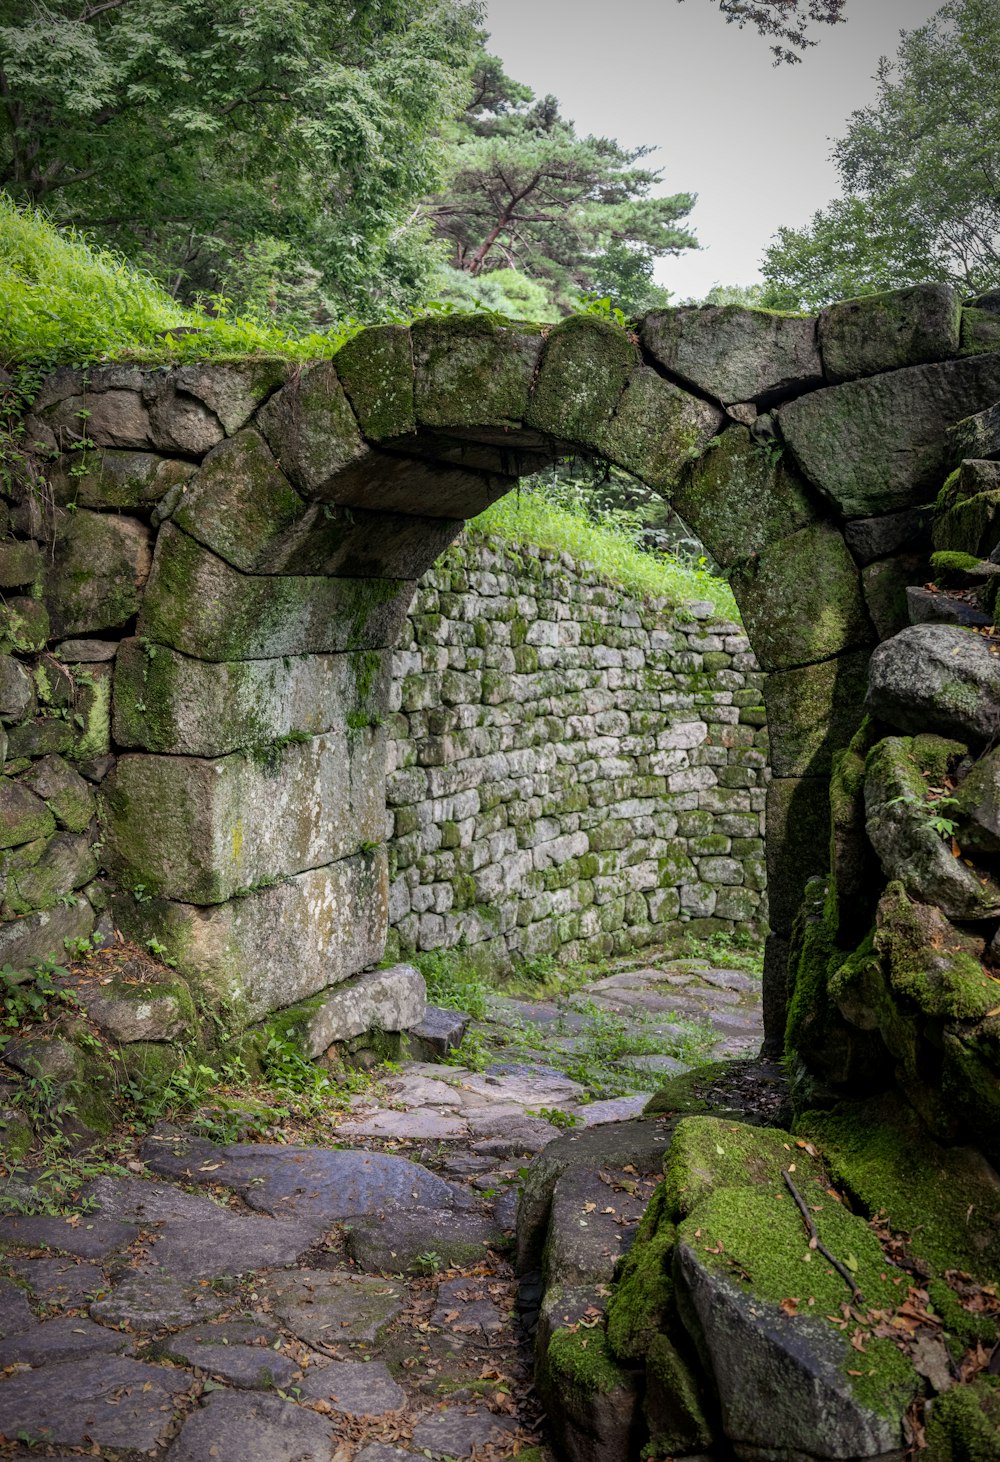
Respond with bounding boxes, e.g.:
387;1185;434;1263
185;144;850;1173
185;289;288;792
45;510;152;635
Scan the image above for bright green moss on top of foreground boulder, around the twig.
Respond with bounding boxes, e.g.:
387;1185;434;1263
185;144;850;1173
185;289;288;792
677;1171;920;1417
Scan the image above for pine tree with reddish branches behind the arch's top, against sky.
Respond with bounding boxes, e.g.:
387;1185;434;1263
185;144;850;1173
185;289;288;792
424;57;697;310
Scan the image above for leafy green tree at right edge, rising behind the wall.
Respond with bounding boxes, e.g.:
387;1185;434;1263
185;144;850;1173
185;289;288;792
762;0;1000;308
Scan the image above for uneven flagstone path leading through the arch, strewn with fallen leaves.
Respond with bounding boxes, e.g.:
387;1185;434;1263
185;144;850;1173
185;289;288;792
0;961;760;1462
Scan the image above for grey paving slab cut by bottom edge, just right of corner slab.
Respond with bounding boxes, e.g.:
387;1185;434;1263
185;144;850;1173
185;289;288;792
165;1390;336;1462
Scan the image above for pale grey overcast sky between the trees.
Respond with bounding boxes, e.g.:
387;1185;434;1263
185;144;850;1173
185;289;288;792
487;0;942;298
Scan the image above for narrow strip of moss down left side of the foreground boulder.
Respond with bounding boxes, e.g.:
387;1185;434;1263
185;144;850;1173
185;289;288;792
608;1183;677;1361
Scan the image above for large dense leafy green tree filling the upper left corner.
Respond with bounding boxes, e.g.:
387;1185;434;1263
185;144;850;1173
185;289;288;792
0;0;478;313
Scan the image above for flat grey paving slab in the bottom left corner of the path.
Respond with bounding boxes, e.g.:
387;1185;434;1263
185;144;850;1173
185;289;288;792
0;1355;185;1455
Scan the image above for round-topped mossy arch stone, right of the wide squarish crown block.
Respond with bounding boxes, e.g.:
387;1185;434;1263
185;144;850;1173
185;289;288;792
525;316;639;449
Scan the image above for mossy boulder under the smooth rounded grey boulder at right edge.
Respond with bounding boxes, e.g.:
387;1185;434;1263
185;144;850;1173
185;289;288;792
864;737;1000;920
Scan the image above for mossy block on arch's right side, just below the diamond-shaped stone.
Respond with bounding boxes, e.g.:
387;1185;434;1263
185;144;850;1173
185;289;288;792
730;523;874;670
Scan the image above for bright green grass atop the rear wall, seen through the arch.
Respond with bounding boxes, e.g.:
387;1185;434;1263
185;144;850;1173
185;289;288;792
469;482;740;623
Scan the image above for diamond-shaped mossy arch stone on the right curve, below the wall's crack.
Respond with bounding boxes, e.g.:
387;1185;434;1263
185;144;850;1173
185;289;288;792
673;425;819;567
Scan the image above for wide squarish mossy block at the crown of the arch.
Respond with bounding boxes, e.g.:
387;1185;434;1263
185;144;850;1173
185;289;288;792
411;316;542;427
